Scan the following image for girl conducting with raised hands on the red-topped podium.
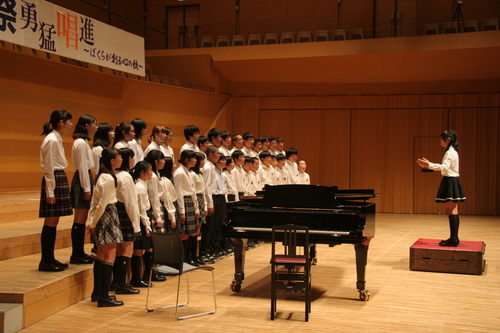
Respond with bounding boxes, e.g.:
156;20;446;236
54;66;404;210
417;130;466;247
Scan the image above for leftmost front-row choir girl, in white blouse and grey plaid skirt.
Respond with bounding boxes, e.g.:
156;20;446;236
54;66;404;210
87;148;123;307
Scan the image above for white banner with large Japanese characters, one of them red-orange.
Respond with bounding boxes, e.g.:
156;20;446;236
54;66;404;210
0;0;145;76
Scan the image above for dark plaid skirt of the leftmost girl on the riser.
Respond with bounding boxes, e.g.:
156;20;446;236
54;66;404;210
38;170;73;217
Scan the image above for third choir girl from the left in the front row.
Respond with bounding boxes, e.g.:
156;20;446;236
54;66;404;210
130;161;153;288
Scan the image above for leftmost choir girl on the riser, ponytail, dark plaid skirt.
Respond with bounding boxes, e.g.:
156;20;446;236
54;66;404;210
38;110;73;272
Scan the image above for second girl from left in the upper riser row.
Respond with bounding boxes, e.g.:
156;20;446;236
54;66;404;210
70;114;98;264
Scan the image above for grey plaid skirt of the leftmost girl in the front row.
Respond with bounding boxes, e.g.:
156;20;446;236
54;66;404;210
90;204;123;246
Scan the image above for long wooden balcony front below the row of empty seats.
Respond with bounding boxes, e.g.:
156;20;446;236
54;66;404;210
146;31;500;95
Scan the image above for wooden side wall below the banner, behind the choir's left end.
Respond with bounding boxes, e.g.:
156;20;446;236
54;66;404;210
0;49;228;191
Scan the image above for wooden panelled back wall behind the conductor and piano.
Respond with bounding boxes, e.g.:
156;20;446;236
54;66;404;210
231;94;500;215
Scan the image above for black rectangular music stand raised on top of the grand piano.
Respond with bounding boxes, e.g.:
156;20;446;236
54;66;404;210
262;184;339;208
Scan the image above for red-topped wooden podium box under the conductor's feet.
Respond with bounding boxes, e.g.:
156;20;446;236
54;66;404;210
410;238;486;275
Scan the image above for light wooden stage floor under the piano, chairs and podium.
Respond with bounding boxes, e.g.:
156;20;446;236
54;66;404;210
18;214;500;333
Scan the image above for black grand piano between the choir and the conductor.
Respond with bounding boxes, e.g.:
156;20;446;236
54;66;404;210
222;185;376;301
